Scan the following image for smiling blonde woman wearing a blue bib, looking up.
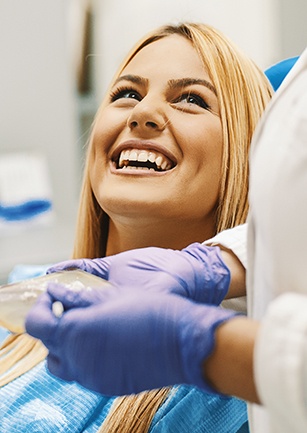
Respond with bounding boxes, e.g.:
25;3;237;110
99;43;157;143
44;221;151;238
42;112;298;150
0;24;271;432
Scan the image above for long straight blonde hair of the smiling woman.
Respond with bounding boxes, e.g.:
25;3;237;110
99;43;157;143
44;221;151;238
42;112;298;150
0;23;272;432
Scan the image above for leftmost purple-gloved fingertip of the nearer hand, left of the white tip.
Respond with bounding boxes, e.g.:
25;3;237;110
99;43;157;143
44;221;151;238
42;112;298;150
25;293;58;345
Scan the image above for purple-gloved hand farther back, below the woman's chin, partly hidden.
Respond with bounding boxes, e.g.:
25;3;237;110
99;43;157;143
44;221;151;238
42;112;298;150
47;243;230;305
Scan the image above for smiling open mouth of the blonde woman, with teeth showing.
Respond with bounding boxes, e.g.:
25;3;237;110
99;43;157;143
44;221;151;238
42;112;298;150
115;148;175;172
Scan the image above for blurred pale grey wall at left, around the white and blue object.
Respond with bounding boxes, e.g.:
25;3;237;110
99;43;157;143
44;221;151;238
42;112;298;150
0;0;79;281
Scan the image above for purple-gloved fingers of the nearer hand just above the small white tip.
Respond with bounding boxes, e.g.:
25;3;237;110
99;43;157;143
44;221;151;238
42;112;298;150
47;283;113;311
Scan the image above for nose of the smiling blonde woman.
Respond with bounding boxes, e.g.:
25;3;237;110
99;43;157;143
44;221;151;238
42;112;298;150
128;97;167;132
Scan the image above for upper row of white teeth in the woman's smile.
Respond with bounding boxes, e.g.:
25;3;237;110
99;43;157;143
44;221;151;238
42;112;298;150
118;149;172;170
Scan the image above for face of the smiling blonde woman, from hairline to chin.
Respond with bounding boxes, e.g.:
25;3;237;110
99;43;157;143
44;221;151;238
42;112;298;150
90;35;223;230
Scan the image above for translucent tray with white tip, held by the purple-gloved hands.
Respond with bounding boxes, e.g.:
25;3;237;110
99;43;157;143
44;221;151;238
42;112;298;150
0;270;112;333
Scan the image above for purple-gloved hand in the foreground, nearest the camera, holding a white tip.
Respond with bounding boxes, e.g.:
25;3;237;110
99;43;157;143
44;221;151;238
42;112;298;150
26;283;236;395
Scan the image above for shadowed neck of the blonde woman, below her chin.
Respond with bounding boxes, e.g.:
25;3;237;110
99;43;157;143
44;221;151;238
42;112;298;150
106;213;215;256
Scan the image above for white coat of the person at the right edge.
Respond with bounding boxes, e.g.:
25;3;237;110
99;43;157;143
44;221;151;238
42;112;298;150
247;49;307;433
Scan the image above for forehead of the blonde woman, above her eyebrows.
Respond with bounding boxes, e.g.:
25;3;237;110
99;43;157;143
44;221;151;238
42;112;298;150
122;35;208;79
